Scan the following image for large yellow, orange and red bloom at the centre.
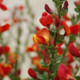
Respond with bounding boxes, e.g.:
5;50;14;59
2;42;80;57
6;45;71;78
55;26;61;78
33;28;50;44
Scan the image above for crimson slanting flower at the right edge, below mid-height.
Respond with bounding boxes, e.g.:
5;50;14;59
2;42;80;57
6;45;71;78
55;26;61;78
68;43;80;57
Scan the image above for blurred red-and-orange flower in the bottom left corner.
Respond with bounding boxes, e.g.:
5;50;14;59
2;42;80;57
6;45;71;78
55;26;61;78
0;63;12;77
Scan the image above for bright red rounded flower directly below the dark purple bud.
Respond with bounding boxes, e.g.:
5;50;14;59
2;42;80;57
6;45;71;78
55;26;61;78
39;12;53;26
